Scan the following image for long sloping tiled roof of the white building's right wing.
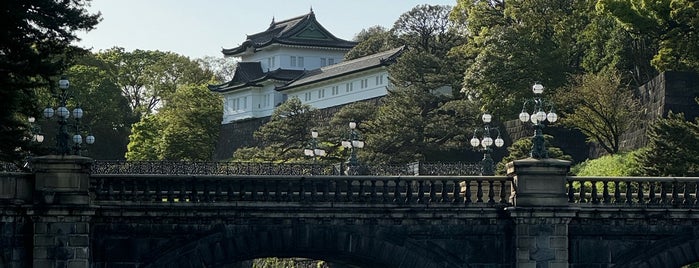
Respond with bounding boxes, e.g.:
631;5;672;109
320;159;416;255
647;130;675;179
277;46;405;91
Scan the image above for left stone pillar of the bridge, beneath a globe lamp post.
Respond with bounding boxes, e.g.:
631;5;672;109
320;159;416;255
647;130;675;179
27;155;94;268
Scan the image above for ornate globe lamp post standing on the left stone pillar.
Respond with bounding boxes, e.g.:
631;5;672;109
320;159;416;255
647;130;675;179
43;77;95;155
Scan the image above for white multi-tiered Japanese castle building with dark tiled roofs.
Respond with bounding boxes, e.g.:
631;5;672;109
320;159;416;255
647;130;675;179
209;10;404;124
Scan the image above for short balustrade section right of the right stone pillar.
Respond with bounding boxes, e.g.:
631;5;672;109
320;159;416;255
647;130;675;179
566;176;699;207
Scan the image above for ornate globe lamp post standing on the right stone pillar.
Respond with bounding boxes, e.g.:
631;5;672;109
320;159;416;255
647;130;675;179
519;82;558;159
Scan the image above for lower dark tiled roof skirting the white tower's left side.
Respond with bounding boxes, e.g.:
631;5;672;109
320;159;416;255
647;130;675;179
208;62;304;92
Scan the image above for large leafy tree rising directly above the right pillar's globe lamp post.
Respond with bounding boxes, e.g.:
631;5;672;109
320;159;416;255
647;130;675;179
452;0;587;115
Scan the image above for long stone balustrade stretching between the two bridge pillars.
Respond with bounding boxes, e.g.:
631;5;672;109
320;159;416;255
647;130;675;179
90;175;511;206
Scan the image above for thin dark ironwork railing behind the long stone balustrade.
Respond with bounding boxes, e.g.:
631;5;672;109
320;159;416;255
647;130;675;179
91;160;481;176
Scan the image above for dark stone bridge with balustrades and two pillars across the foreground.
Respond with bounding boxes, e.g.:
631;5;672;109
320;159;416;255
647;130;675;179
0;156;699;268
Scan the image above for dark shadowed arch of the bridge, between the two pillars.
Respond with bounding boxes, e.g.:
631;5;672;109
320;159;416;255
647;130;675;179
143;226;464;268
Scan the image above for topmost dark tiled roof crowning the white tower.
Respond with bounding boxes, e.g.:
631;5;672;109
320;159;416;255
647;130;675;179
222;11;357;56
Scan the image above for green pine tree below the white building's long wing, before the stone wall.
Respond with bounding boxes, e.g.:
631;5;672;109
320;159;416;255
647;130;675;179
233;97;318;162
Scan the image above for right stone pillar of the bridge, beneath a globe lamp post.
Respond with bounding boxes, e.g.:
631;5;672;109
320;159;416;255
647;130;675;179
507;158;577;268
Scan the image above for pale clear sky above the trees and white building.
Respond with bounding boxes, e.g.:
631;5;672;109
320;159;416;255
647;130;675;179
78;0;456;58
